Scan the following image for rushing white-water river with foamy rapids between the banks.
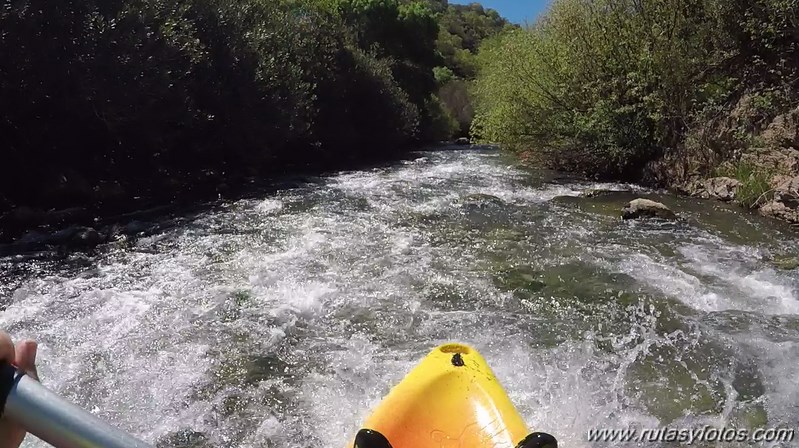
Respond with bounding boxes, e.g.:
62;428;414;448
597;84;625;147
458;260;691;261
0;149;799;448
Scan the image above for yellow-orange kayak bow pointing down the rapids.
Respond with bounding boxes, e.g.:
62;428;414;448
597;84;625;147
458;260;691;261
347;344;557;448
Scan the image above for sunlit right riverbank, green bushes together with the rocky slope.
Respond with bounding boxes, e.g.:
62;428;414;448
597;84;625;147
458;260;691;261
473;0;799;224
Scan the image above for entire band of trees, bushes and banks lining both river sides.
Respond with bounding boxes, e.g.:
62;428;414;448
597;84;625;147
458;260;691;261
0;0;799;245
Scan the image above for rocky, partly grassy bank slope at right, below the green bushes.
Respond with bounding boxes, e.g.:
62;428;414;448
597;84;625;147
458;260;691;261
651;94;799;227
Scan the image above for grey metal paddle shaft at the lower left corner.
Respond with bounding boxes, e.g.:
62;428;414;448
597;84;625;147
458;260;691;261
0;364;152;448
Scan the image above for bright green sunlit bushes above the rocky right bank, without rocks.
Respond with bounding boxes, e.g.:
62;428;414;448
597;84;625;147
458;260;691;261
473;0;799;178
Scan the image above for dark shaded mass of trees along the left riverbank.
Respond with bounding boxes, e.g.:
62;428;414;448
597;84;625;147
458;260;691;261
0;0;441;210
